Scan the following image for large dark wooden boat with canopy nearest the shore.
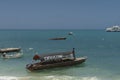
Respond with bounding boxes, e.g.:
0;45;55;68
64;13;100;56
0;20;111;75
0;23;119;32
26;49;87;71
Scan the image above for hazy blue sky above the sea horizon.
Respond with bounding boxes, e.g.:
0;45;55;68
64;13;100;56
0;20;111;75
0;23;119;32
0;0;120;29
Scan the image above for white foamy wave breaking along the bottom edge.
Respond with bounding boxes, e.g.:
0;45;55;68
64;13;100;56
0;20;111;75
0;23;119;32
0;76;101;80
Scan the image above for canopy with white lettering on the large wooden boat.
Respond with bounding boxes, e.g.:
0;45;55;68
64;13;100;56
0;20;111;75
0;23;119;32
33;48;75;63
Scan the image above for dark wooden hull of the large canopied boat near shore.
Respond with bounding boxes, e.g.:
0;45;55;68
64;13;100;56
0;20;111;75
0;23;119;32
26;58;86;71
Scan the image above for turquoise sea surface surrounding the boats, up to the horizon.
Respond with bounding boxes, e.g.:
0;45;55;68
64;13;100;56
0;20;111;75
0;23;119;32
0;30;120;80
